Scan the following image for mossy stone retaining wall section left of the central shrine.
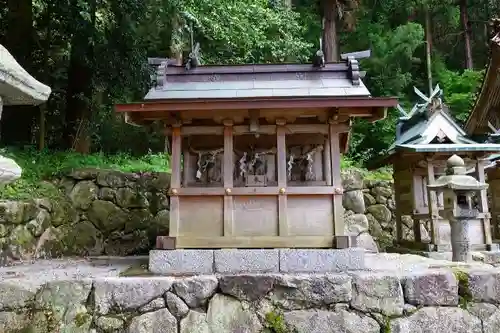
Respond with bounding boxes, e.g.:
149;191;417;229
0;169;170;259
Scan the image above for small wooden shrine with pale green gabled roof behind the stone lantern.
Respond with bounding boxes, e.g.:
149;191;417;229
377;86;500;252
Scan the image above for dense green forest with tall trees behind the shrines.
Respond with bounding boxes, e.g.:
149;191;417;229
0;0;500;196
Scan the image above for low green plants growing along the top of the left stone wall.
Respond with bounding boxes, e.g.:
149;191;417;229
0;149;170;199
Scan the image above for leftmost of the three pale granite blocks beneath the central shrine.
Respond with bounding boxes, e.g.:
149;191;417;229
149;250;214;275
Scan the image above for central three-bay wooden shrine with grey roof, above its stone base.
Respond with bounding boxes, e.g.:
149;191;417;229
116;58;397;249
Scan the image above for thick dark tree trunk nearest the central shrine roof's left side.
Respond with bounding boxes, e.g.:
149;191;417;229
63;0;96;154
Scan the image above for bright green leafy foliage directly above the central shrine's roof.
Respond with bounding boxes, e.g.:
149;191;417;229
180;0;312;64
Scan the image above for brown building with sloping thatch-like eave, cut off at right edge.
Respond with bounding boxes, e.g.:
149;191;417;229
465;19;500;239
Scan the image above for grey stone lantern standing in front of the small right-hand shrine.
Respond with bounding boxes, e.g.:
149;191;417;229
427;155;488;262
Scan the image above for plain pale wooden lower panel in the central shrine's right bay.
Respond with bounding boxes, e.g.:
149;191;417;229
287;195;334;236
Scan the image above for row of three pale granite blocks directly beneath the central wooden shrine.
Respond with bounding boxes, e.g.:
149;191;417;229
149;248;366;275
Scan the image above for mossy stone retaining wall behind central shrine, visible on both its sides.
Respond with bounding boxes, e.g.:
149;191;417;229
0;169;402;264
